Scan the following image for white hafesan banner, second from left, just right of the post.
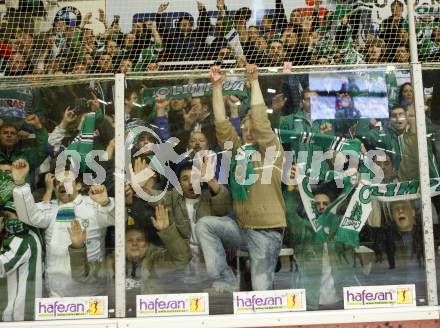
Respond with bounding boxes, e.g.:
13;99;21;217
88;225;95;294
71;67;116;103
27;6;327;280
136;293;209;318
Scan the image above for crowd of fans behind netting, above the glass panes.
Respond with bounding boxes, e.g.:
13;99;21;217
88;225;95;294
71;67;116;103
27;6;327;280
0;0;440;76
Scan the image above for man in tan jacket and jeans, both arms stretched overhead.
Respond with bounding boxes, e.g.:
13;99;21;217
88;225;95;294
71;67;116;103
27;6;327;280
196;65;286;292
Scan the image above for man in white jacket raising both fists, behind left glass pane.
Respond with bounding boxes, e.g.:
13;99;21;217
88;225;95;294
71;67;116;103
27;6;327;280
12;160;115;297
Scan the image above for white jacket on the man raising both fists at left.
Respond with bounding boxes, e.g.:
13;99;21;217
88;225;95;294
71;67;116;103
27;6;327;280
13;184;115;297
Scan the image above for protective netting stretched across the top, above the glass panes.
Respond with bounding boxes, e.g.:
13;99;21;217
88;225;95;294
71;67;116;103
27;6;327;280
0;0;440;75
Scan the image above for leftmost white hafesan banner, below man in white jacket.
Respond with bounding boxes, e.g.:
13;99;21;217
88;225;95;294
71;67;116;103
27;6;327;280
35;296;108;320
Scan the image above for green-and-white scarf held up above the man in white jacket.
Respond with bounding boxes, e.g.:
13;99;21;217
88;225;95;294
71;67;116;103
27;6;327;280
67;113;96;172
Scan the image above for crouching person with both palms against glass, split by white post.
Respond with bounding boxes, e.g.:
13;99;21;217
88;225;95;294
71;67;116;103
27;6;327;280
69;205;191;305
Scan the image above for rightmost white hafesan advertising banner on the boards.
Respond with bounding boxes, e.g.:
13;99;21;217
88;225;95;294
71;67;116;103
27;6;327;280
344;285;416;309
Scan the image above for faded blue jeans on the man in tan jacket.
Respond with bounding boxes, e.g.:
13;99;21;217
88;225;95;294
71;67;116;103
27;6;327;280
196;216;283;291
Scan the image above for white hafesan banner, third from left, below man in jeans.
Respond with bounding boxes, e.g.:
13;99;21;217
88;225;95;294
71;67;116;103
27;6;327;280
233;289;306;314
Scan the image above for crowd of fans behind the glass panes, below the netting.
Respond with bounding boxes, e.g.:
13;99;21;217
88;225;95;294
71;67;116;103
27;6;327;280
0;61;439;321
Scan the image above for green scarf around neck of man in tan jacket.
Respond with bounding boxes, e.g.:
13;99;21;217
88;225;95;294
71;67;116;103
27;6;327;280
229;146;258;200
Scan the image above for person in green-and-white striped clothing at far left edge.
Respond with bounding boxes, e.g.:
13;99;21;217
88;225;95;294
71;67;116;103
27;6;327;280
0;202;43;321
